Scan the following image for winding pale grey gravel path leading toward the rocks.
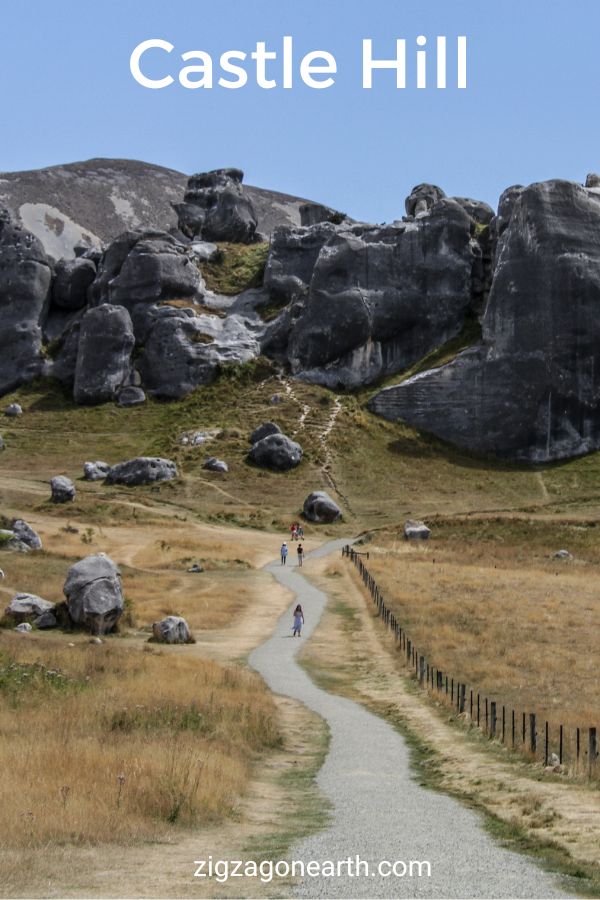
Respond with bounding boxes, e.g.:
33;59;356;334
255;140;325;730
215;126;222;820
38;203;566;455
250;541;568;898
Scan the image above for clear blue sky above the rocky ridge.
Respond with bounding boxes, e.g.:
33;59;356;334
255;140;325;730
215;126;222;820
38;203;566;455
0;0;600;221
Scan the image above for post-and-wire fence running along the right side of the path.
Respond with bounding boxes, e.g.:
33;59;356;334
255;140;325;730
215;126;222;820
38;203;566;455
342;545;600;779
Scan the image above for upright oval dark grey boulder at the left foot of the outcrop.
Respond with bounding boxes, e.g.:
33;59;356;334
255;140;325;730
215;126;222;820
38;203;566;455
73;303;135;403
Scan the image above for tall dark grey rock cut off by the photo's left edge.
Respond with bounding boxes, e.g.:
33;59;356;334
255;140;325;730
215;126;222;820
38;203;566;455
0;207;52;396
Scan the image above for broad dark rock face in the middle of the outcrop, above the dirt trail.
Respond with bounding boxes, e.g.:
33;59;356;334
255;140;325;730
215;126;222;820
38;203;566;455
264;199;482;389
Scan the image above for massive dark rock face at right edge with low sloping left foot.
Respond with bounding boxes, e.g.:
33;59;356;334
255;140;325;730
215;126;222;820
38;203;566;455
369;181;600;462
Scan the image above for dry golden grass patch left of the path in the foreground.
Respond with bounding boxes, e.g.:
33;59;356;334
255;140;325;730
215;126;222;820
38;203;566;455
0;633;280;847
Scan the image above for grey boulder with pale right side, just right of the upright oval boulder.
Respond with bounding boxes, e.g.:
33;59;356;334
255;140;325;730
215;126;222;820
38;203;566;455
138;307;261;399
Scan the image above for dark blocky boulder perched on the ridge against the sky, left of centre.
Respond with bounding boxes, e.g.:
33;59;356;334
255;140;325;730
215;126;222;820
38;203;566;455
175;169;258;244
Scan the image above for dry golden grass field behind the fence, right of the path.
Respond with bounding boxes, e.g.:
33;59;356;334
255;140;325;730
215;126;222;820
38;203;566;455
359;519;600;727
